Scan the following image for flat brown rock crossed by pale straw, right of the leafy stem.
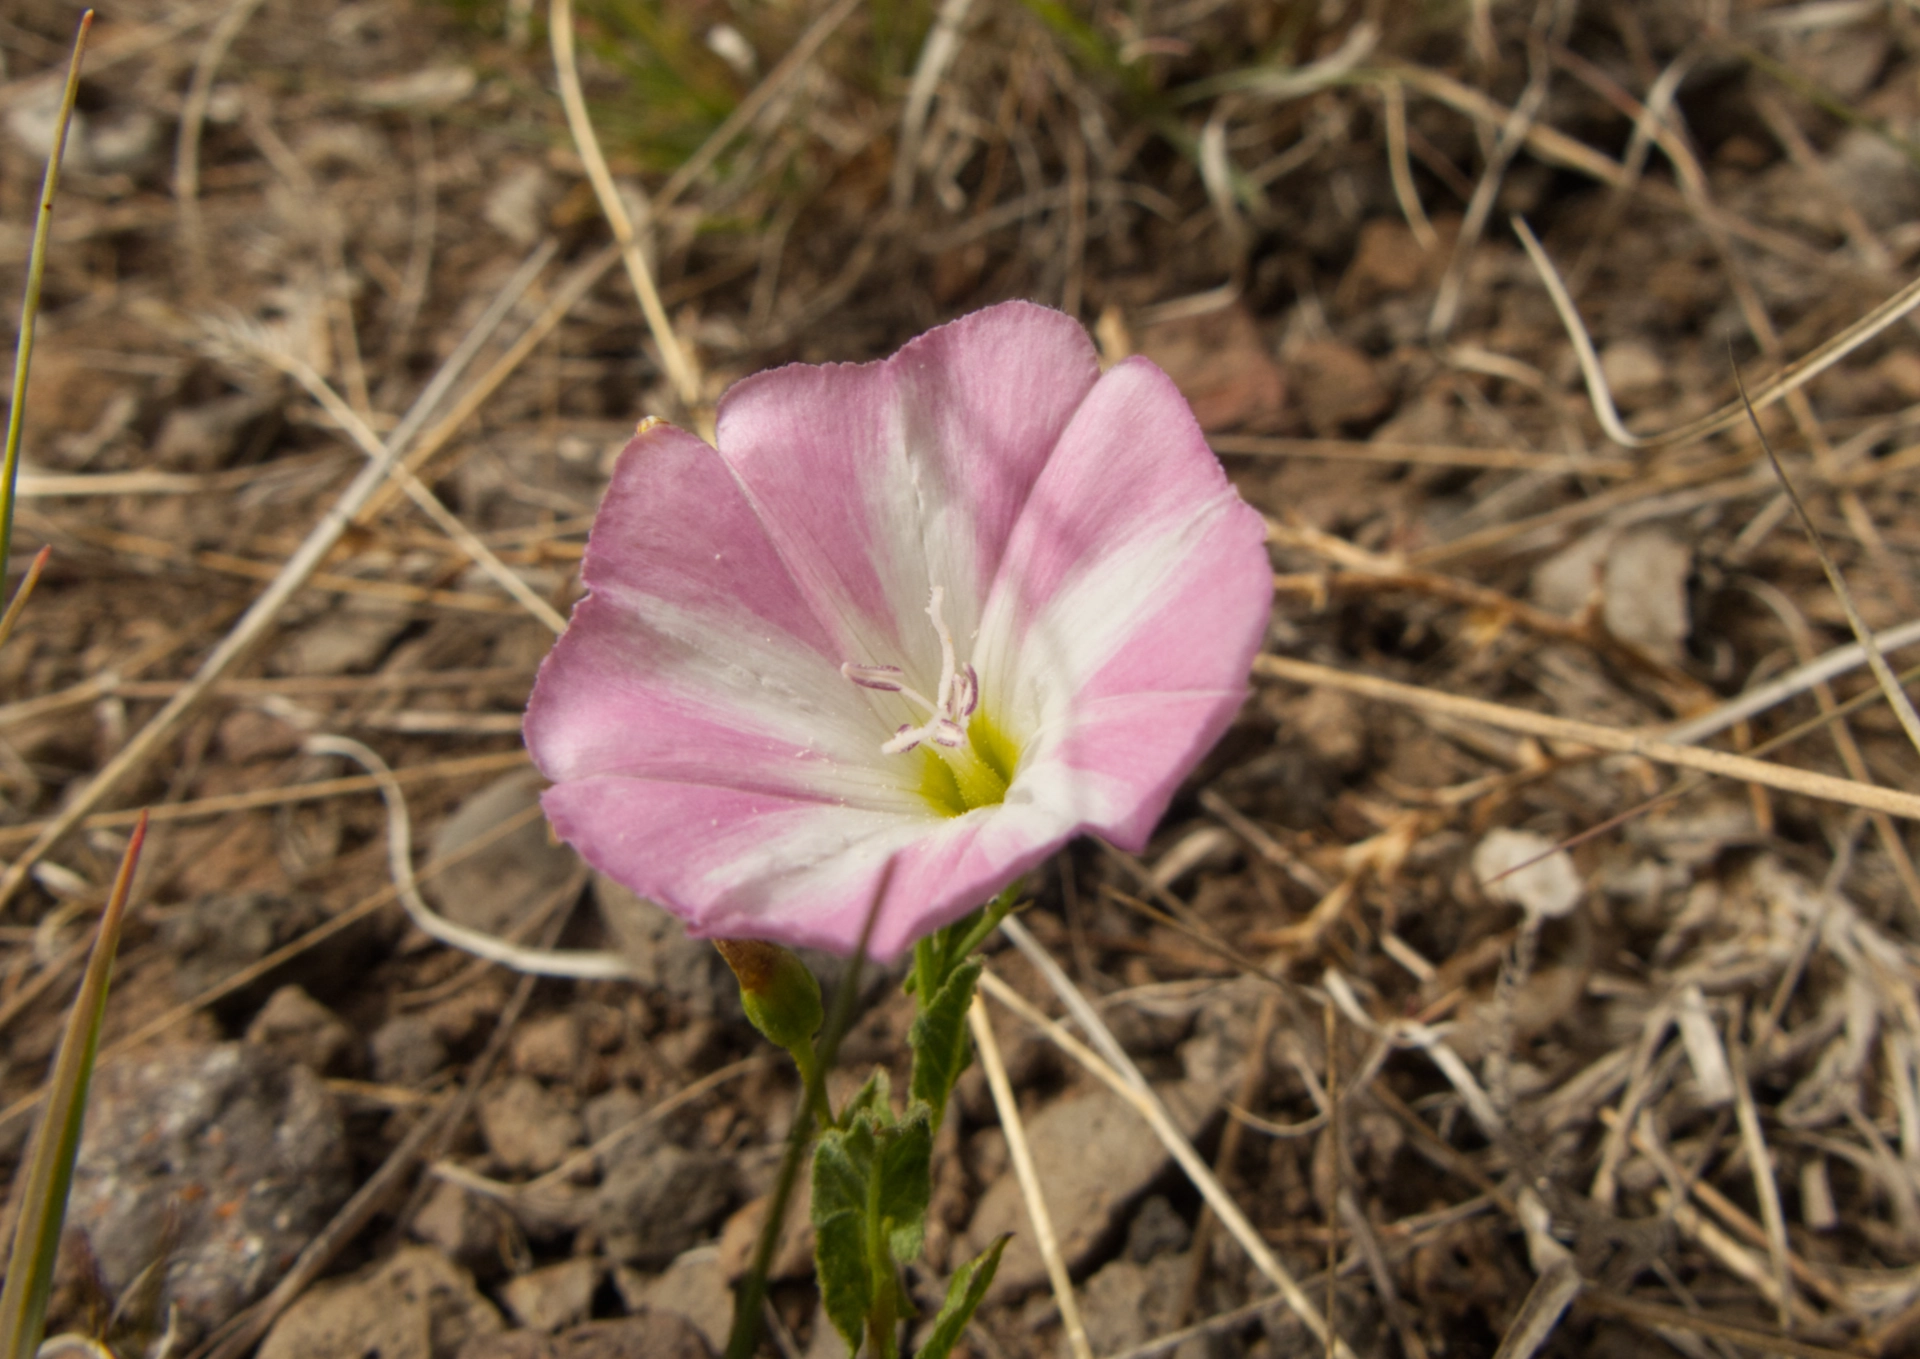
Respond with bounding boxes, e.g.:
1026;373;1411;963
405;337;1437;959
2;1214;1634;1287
968;1088;1167;1298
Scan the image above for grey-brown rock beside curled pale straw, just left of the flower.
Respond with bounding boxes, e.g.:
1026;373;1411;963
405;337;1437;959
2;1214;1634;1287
420;770;580;935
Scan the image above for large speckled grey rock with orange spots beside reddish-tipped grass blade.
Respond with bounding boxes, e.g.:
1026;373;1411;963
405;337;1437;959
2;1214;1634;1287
67;1042;353;1344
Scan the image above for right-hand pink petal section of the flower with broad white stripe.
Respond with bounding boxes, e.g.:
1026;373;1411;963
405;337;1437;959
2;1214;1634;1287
975;359;1273;845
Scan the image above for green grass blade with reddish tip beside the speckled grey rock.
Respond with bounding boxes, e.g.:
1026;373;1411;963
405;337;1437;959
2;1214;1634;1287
0;812;146;1359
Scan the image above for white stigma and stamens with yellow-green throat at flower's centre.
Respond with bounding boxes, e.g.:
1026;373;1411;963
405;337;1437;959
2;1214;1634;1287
841;585;1020;816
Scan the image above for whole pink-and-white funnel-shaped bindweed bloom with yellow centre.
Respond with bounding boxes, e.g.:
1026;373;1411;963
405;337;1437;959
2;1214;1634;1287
526;303;1273;958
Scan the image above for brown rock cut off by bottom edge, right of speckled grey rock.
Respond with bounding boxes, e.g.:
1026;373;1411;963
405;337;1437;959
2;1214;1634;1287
259;1246;503;1359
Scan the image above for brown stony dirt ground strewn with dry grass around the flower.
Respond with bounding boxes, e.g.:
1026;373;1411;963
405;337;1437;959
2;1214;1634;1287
0;0;1920;1359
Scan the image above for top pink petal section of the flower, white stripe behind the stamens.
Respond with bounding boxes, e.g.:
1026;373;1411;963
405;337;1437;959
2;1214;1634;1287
718;303;1098;687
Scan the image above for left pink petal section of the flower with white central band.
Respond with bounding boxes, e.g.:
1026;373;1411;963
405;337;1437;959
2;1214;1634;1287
526;426;924;810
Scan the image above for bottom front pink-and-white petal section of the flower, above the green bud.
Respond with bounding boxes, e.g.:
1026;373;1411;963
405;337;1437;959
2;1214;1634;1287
541;777;1069;960
